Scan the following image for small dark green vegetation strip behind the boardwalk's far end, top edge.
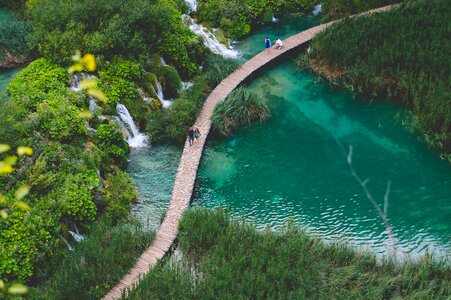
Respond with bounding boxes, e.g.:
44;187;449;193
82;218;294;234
321;0;402;19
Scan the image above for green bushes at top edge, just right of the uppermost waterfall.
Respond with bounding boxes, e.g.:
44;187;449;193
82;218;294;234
196;0;317;39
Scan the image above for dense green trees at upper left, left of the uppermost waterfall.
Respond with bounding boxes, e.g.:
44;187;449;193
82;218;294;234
29;0;202;78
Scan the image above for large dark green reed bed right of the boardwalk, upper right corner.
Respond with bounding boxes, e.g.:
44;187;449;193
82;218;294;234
304;0;451;157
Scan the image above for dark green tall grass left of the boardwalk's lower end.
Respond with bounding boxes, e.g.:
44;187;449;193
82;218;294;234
30;217;154;300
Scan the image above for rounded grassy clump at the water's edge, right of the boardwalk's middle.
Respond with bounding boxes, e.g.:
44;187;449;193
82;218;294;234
211;87;271;136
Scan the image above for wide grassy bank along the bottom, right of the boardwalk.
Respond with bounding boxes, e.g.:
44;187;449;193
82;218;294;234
128;209;451;299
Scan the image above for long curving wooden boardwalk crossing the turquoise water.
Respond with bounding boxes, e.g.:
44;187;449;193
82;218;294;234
103;6;391;300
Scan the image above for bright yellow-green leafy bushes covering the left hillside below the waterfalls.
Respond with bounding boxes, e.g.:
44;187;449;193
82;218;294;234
0;59;136;281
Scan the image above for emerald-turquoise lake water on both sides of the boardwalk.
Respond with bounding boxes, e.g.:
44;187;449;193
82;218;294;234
129;14;451;256
